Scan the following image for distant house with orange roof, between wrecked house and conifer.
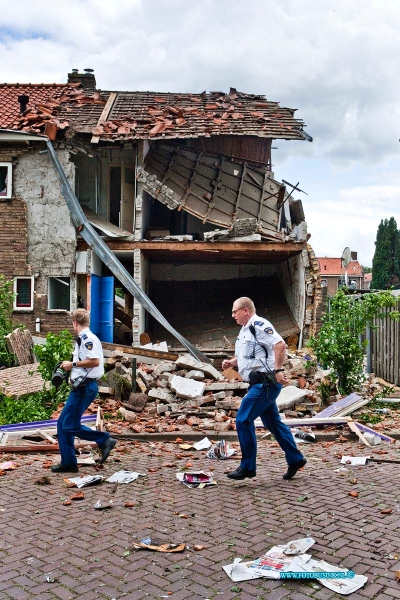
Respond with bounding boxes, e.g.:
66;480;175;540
317;252;364;296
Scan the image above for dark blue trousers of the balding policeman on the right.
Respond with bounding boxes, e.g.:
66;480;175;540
236;383;303;471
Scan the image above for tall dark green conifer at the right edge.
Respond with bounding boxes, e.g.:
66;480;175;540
371;217;400;290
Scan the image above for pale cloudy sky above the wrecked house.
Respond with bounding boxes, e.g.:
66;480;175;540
0;0;400;265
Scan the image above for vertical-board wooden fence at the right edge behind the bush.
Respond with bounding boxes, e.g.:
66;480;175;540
367;302;400;385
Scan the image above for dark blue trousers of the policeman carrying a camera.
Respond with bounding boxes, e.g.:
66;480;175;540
57;381;110;467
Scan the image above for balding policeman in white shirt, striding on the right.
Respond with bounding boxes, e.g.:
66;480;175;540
222;297;307;479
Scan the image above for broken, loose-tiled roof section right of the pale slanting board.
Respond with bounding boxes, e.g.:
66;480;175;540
93;88;311;140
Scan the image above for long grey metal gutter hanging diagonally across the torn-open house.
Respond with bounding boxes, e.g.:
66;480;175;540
46;139;211;363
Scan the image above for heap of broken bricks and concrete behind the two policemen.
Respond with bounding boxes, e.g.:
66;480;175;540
93;351;338;433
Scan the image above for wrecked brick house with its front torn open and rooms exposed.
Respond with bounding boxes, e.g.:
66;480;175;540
0;70;319;350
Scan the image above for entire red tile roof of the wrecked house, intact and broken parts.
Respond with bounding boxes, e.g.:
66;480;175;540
0;84;311;141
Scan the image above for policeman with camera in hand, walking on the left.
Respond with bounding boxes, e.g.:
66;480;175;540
51;308;117;473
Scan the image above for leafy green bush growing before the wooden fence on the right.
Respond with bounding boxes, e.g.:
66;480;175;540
308;289;400;394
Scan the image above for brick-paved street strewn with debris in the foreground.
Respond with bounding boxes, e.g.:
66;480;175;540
0;441;400;600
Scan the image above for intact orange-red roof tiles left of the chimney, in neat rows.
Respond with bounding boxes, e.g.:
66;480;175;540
0;83;76;129
